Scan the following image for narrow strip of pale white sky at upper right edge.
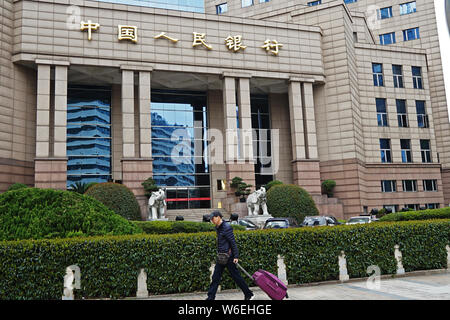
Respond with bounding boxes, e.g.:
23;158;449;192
434;0;450;119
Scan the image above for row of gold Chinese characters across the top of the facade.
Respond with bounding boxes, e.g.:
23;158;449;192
80;20;283;56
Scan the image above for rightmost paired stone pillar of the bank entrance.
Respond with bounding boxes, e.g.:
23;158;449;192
289;78;321;195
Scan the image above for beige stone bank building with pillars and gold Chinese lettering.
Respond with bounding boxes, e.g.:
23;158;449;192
0;0;450;220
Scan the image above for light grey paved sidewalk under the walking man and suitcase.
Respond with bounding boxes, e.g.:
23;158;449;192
136;270;450;300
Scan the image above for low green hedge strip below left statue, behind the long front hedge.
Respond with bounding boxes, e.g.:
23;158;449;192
133;221;245;234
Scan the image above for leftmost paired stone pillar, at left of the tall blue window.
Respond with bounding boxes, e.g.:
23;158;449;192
34;61;69;190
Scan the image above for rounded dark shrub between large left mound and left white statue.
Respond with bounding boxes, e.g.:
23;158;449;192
85;182;141;220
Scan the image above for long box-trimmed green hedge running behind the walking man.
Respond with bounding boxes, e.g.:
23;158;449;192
0;220;450;299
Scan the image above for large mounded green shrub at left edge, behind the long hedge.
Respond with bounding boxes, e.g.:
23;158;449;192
0;188;142;240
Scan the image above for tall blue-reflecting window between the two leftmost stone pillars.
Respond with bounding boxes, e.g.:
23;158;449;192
67;86;111;188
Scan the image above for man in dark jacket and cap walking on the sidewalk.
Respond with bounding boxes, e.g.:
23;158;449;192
206;211;254;300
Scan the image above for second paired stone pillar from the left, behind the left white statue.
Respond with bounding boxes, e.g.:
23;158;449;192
121;68;153;220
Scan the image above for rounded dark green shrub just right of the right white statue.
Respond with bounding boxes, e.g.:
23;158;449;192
267;184;319;224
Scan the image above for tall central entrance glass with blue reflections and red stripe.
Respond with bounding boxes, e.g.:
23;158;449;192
150;90;211;209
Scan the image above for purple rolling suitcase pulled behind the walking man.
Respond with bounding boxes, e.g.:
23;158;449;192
237;263;289;300
